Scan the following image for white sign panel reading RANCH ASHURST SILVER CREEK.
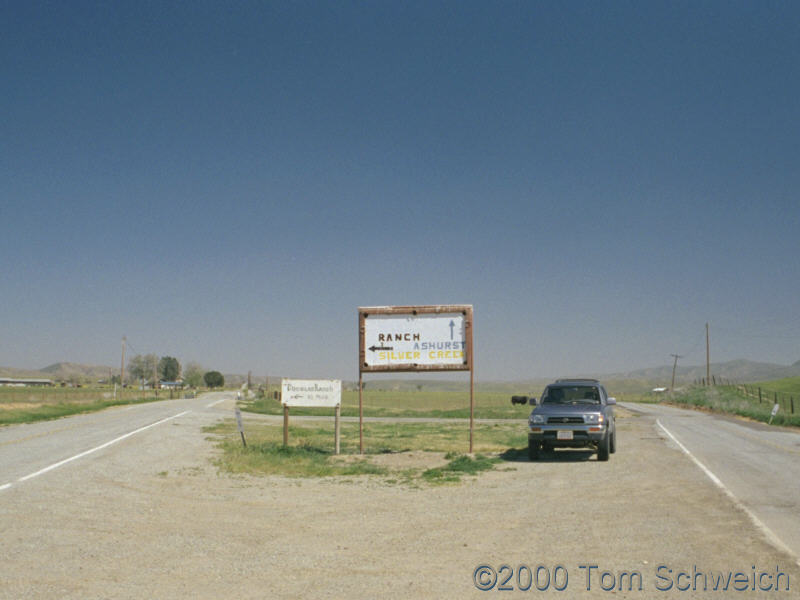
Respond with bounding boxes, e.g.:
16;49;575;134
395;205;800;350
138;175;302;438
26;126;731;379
362;311;469;369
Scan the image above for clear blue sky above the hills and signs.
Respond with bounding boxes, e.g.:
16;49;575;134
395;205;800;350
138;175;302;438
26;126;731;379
0;1;800;380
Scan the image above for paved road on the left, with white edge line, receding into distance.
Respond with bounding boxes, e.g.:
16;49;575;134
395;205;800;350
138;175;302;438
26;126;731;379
0;392;235;493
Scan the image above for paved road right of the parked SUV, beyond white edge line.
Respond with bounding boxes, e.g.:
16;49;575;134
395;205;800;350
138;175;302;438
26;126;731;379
624;403;800;564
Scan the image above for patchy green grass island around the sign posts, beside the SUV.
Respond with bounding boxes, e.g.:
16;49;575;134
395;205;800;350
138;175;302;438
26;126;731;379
206;420;526;486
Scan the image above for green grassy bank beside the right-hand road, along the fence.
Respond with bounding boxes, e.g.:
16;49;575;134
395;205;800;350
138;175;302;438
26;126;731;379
665;382;800;427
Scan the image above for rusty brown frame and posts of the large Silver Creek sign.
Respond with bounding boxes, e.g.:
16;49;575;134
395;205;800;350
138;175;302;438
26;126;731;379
358;304;475;454
